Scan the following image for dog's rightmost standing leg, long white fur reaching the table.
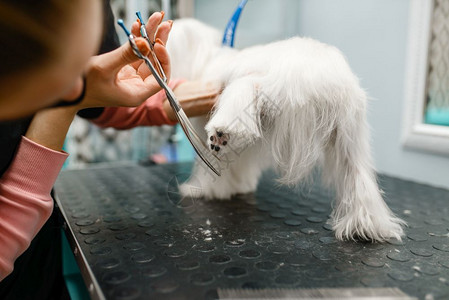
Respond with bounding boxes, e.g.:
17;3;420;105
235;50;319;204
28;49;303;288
323;94;405;242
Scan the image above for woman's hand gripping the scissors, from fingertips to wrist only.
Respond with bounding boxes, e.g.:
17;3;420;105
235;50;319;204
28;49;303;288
78;13;172;109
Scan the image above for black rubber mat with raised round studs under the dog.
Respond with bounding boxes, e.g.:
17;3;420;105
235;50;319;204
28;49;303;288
56;164;449;299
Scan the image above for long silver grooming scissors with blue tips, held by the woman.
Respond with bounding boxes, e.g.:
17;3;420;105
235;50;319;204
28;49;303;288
117;17;221;176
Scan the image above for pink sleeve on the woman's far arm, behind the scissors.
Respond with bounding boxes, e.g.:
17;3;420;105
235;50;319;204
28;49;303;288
91;80;183;129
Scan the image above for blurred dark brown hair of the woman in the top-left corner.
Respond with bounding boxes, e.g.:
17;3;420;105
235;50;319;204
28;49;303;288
0;0;77;78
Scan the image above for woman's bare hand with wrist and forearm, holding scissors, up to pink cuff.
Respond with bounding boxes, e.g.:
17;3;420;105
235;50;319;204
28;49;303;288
26;13;171;151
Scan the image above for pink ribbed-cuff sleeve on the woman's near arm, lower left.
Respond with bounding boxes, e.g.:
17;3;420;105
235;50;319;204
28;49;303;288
0;137;68;281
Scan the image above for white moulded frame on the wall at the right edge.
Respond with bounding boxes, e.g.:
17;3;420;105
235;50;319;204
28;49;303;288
402;0;449;156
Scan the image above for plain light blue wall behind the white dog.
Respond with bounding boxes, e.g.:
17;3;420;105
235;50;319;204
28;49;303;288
195;0;449;188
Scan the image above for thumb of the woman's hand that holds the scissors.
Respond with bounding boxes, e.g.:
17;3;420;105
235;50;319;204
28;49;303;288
97;37;150;74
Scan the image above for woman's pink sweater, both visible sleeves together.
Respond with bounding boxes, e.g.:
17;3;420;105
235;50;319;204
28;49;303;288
0;80;181;281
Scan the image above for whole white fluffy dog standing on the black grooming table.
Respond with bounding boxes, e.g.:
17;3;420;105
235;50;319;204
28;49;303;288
167;19;404;241
